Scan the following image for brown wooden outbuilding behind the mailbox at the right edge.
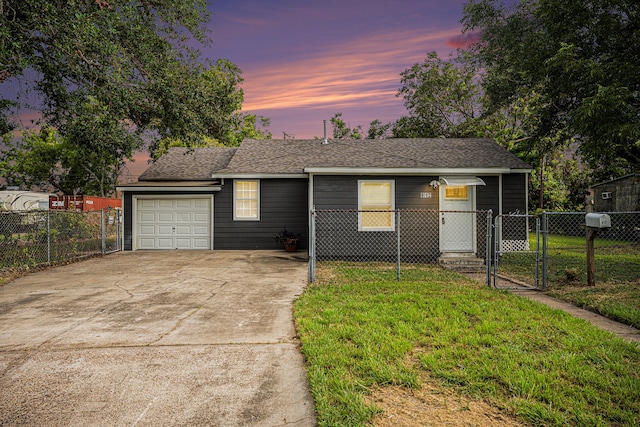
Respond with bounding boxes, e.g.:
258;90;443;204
587;173;640;212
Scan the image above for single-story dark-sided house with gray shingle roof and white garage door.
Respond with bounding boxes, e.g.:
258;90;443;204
118;138;531;252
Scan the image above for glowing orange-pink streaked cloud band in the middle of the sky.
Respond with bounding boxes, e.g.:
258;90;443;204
244;28;459;114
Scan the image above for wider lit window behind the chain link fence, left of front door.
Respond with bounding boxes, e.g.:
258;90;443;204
358;181;395;231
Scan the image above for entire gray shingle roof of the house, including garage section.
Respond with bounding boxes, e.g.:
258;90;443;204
140;138;531;181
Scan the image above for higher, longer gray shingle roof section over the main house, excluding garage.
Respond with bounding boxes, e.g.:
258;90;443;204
218;138;531;174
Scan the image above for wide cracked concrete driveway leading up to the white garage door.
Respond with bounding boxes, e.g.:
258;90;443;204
0;251;315;426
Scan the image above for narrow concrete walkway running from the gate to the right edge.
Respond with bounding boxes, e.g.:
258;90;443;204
467;274;640;343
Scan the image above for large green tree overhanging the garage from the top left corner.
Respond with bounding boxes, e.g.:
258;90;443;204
0;0;268;193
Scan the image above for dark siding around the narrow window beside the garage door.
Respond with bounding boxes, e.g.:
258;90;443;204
213;178;309;250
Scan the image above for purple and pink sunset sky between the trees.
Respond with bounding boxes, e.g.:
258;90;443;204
202;0;480;138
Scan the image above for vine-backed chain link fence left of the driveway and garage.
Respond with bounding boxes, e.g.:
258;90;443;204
0;209;122;268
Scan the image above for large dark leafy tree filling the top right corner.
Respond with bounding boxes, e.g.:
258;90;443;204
463;0;640;179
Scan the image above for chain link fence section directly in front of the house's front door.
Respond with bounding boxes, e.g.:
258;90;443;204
309;210;491;281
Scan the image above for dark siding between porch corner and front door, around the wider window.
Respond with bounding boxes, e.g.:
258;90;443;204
313;175;439;262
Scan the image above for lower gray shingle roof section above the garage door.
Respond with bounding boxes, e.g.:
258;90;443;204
138;147;236;181
